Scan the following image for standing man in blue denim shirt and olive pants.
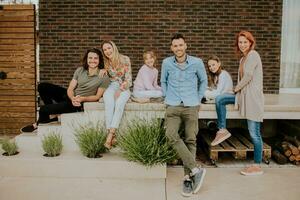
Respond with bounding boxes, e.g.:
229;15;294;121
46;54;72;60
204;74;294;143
161;34;207;196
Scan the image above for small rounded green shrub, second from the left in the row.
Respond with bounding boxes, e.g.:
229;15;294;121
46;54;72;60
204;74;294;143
42;132;63;157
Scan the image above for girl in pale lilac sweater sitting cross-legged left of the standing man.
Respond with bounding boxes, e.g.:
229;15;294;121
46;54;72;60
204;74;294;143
132;50;163;103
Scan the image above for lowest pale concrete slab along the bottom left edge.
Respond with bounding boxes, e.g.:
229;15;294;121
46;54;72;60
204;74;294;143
0;177;166;200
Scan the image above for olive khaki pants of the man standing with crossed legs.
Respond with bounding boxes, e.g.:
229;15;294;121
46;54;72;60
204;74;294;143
165;105;199;175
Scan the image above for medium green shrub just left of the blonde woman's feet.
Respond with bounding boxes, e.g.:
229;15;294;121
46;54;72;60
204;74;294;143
75;123;106;158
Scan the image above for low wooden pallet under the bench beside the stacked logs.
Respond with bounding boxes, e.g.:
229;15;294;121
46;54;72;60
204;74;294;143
201;133;271;163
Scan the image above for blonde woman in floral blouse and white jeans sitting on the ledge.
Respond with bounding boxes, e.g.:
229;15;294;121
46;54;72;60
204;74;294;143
101;41;132;149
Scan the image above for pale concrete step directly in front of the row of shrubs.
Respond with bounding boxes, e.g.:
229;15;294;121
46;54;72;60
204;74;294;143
0;149;166;179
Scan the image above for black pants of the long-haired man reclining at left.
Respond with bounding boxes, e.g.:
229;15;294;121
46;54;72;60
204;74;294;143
37;83;83;124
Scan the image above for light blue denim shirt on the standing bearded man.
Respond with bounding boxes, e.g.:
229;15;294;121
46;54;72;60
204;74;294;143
160;55;207;106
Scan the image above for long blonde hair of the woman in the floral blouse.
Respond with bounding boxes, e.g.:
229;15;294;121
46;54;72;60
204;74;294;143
101;40;122;69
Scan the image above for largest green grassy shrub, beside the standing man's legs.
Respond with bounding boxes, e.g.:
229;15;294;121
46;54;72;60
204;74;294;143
118;119;176;167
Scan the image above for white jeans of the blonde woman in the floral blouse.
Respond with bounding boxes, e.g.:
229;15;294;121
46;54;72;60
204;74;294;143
103;81;130;129
